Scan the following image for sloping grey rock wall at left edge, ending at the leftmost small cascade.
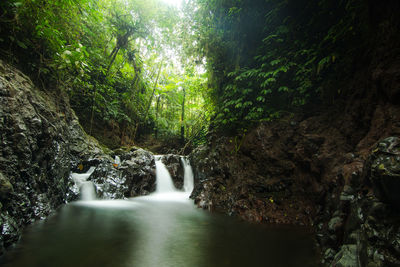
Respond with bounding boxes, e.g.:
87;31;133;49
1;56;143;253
0;58;101;253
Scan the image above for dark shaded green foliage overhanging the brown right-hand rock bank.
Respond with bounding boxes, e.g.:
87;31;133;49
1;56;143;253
189;0;367;132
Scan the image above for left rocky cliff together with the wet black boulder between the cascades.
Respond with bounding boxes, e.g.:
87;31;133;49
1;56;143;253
0;61;155;254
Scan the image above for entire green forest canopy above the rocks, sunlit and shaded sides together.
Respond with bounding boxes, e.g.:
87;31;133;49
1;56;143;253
0;0;391;145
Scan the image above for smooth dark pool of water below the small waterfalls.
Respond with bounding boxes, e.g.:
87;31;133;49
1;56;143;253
0;198;317;267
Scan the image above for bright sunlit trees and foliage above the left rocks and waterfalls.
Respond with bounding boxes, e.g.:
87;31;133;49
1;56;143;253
0;0;207;149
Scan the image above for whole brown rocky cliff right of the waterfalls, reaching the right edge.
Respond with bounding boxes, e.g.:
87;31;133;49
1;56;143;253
191;45;400;266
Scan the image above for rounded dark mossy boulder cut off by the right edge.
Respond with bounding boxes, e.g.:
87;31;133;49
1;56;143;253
368;137;400;208
